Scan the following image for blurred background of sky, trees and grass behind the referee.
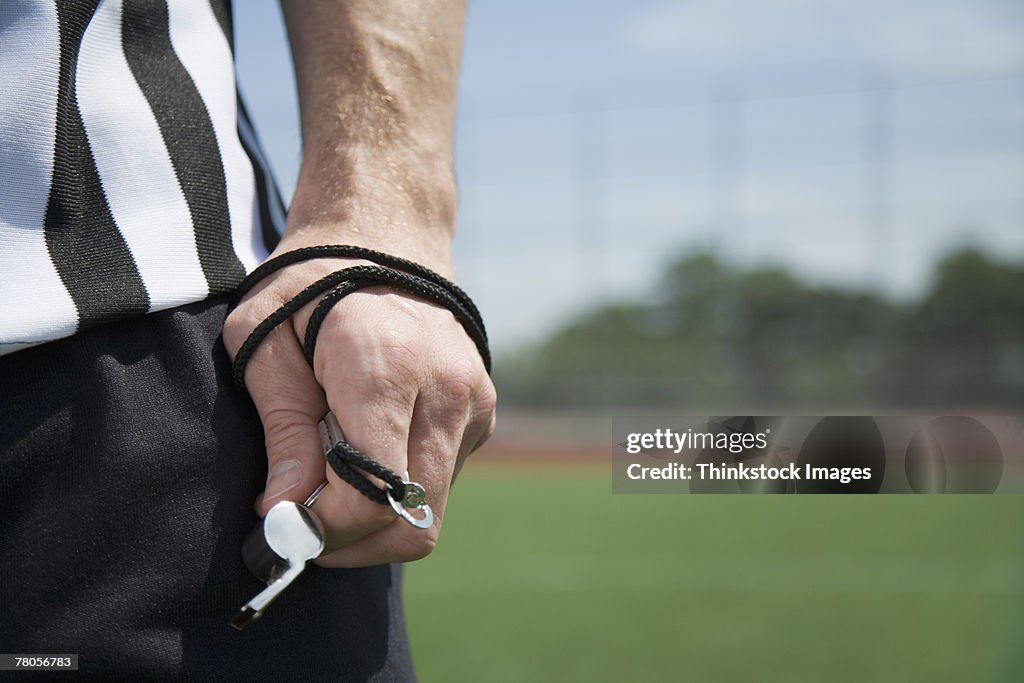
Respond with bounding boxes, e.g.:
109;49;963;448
236;0;1024;681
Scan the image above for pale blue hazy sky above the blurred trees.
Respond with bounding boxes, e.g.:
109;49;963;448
236;0;1024;351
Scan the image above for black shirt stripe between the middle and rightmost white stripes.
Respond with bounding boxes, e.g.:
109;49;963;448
121;0;245;294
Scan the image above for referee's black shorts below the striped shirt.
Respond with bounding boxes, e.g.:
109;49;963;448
0;298;414;681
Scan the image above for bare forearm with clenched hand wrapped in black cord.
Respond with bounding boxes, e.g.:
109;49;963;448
224;0;495;566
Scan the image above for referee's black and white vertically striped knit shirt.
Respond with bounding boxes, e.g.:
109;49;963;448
0;0;284;354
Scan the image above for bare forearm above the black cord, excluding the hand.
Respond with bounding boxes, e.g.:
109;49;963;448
283;0;464;270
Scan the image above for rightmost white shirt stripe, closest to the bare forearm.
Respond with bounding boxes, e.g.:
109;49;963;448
167;2;267;272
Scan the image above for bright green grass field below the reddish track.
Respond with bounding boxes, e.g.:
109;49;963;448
406;466;1024;683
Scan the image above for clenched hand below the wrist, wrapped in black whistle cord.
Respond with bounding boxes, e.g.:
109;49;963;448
224;240;495;566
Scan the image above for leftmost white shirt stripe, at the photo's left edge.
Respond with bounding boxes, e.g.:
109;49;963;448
0;0;78;354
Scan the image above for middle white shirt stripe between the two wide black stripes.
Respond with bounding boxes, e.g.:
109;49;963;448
77;0;209;310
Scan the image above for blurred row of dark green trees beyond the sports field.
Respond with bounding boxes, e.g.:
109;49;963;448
498;249;1024;413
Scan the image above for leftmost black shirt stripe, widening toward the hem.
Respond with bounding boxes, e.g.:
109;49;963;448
43;0;150;330
